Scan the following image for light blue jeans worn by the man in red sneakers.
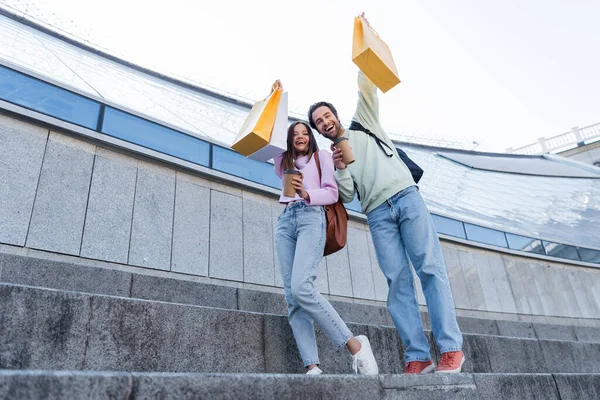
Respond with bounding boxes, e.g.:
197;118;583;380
367;186;462;362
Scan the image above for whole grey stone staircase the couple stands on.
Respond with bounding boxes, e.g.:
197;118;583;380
0;253;600;399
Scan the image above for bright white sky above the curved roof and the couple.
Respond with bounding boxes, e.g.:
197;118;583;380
5;0;600;152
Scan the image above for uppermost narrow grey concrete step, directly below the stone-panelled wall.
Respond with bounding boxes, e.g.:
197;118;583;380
0;252;600;343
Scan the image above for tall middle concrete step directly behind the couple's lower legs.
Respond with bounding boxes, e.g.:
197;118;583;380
0;284;600;374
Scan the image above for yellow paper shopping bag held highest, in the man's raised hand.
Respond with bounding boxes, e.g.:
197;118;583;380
352;17;400;93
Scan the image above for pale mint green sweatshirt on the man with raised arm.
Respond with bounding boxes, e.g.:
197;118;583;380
335;71;415;214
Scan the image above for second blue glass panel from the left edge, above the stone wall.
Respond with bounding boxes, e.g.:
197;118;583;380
102;107;210;167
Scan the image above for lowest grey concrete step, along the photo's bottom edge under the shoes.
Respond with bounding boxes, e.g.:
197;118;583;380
0;370;600;400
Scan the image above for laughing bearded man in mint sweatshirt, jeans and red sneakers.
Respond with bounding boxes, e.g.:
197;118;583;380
308;71;465;374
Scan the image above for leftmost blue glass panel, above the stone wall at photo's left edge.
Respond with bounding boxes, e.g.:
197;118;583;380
0;65;100;130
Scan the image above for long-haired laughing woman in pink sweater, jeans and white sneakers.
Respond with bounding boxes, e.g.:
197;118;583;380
273;81;379;375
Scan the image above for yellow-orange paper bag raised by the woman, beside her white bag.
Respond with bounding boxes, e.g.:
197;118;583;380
231;90;282;157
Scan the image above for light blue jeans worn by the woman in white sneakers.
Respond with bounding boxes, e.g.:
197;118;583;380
275;201;352;367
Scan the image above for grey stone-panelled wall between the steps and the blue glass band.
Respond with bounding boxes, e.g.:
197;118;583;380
0;115;600;325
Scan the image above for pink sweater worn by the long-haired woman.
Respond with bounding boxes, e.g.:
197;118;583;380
274;150;338;206
